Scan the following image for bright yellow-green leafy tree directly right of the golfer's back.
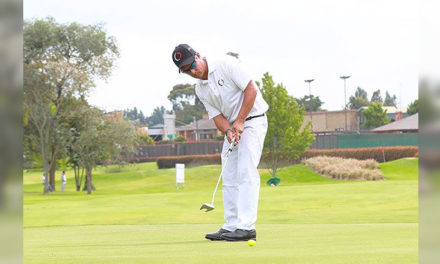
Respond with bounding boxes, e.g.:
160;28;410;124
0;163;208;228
257;73;315;183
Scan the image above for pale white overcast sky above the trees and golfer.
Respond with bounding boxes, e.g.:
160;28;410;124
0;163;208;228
23;0;420;115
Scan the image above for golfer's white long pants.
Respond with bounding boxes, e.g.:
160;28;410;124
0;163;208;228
222;116;267;231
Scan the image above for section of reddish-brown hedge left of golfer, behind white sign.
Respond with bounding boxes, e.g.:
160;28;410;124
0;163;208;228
156;154;221;169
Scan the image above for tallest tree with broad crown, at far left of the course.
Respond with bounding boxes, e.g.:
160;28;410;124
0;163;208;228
23;18;119;192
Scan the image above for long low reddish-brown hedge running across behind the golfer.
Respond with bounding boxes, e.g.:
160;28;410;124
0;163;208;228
155;146;419;169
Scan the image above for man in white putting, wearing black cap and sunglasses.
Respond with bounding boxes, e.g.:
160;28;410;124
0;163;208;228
172;44;269;241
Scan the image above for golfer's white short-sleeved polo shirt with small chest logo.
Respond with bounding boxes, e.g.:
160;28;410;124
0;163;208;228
195;56;269;123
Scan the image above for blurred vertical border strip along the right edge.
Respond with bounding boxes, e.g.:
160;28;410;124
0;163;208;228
419;1;440;263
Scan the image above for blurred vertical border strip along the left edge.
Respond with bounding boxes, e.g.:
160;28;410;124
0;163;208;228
0;0;23;263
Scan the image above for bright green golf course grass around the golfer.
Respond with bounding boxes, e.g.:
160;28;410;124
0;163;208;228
23;159;418;264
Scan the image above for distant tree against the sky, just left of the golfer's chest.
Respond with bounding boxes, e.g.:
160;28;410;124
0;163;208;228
168;84;206;124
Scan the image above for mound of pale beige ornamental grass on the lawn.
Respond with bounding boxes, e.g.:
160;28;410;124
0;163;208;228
303;156;383;181
